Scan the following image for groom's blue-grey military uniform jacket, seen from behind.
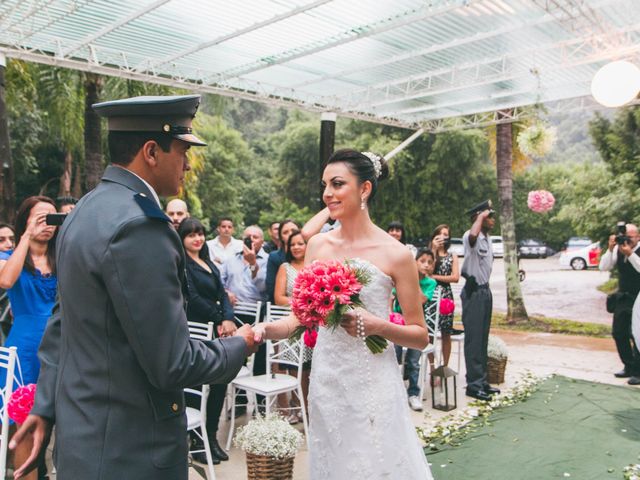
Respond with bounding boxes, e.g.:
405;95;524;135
32;166;247;480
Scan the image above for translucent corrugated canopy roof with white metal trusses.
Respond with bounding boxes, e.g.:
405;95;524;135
0;0;640;132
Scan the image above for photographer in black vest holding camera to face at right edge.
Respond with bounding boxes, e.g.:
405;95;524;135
600;222;640;385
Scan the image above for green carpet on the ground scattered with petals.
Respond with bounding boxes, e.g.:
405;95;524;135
427;376;640;480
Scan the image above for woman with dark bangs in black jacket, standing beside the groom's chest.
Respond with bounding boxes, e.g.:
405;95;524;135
178;217;237;465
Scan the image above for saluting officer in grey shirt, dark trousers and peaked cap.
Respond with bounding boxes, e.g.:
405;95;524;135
461;200;500;400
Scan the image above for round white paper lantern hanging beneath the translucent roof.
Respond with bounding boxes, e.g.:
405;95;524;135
591;60;640;107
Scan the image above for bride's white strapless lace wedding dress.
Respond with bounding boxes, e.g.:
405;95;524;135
309;260;433;480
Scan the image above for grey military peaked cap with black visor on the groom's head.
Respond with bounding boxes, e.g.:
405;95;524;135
92;95;206;146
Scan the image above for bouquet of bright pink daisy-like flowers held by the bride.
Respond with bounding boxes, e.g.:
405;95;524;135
290;260;387;353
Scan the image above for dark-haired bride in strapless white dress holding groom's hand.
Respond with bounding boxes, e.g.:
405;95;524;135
256;150;432;480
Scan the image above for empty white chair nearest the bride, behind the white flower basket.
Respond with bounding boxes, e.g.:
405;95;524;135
227;304;309;450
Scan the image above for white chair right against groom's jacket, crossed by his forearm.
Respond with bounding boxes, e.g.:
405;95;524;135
184;322;216;480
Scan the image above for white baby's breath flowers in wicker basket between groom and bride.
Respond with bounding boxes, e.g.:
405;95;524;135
234;415;302;459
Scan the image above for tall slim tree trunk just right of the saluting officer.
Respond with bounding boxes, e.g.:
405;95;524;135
495;110;529;323
